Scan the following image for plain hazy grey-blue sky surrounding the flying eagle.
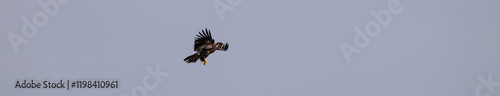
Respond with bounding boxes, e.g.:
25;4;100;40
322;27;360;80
0;0;500;96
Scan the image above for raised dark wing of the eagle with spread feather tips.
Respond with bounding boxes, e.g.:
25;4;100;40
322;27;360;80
194;28;215;51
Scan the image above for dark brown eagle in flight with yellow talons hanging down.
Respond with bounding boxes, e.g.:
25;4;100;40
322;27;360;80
184;28;229;65
